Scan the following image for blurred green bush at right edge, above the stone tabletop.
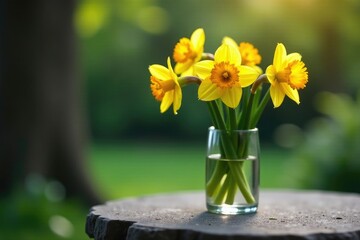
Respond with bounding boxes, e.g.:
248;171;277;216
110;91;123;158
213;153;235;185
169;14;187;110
289;91;360;193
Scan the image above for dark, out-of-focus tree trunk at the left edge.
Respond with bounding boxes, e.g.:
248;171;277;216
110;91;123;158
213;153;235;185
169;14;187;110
0;0;100;205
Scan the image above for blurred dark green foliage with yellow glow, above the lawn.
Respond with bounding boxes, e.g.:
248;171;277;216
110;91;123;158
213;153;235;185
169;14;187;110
75;0;360;139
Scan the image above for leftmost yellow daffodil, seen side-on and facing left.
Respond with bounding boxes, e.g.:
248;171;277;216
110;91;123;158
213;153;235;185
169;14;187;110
149;57;182;114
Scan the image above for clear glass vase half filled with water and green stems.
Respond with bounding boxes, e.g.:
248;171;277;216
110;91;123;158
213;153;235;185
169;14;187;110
206;127;260;214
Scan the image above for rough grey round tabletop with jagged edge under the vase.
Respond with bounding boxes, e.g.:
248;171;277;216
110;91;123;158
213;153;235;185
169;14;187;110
86;190;360;240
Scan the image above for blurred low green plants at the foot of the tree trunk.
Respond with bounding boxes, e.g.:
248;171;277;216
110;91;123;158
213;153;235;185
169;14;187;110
0;183;88;240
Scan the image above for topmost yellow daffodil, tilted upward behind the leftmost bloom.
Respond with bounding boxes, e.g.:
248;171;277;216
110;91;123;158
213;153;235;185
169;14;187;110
173;28;205;74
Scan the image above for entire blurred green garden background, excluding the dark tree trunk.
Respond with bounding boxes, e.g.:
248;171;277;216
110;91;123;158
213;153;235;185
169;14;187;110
0;0;360;239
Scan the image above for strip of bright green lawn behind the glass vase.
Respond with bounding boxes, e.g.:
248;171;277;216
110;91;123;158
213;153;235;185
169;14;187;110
90;143;289;199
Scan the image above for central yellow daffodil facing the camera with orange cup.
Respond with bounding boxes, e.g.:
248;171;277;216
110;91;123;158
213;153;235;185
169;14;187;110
194;44;259;108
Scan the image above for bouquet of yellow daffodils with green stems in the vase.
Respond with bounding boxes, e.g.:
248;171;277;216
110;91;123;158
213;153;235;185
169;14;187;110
149;28;308;214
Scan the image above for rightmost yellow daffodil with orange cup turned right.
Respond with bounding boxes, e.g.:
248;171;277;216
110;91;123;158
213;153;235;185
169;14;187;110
266;43;308;108
